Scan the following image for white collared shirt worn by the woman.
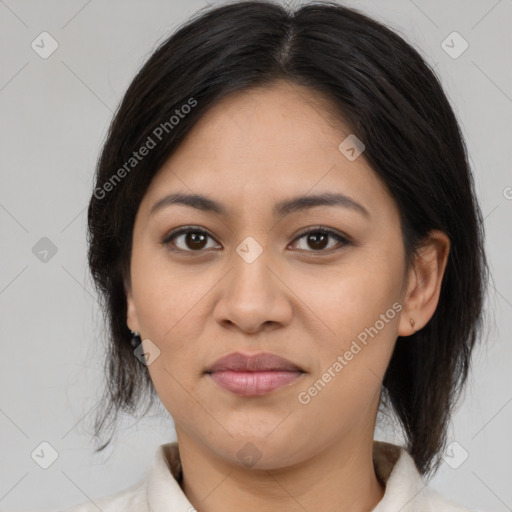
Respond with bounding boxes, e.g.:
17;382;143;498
62;441;476;512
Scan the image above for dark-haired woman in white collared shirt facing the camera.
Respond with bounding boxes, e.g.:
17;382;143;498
63;2;488;512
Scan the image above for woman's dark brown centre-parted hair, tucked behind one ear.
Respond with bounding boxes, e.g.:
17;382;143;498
88;1;488;473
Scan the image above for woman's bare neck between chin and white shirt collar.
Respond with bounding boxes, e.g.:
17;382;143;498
176;426;384;512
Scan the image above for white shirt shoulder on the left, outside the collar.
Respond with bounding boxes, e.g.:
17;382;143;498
59;479;150;512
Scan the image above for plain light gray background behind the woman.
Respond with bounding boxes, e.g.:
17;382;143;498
0;0;512;511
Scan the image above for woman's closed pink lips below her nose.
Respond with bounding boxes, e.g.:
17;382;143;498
205;352;305;396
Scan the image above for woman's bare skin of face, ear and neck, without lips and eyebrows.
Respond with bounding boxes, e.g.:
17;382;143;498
126;82;449;511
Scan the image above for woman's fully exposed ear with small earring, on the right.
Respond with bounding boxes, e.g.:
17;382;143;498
398;230;450;336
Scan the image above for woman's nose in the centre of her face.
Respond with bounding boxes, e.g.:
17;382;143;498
214;245;293;334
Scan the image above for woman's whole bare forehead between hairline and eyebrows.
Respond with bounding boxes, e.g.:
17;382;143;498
145;82;398;222
